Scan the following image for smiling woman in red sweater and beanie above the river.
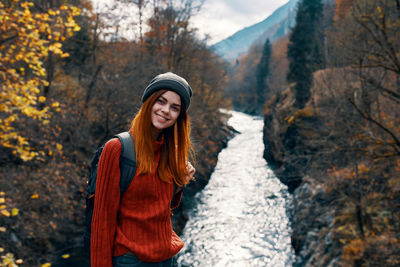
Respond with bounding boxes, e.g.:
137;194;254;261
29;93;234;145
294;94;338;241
91;72;195;267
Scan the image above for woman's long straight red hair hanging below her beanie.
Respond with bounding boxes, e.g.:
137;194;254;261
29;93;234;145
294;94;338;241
129;90;194;186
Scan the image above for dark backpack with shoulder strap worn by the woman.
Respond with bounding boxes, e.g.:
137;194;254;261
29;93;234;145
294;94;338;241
83;132;136;253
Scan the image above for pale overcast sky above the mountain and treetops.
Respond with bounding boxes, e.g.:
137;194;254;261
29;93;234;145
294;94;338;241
92;0;289;45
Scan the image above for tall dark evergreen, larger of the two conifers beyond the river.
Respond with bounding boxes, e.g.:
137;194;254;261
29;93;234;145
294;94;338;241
287;0;324;108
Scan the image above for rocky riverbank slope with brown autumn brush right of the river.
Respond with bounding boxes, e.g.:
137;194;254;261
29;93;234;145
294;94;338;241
263;70;400;266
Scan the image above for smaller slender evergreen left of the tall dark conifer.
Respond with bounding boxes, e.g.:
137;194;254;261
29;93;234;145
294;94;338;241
257;39;271;112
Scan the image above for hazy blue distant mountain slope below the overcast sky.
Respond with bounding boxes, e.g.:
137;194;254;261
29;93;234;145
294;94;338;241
211;0;299;61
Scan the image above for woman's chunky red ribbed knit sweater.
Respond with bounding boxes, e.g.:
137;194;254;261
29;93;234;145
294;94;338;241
91;138;183;267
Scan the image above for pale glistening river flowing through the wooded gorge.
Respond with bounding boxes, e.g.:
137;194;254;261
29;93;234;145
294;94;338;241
176;111;294;267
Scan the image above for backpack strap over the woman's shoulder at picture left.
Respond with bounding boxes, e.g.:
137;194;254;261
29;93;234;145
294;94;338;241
114;132;136;196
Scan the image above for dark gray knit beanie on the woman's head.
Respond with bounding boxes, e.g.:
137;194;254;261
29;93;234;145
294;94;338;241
142;72;192;110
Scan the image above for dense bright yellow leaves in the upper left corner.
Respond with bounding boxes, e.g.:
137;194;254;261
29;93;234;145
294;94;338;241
0;0;80;161
